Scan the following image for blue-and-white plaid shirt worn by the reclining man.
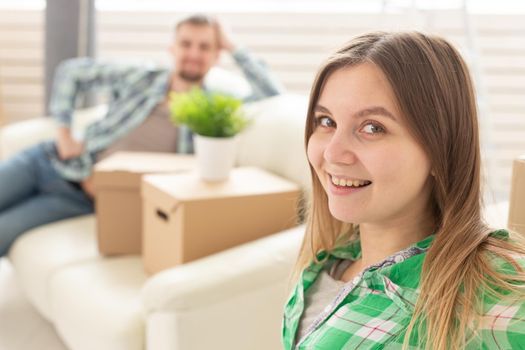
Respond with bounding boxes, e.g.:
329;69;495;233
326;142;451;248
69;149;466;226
44;49;282;181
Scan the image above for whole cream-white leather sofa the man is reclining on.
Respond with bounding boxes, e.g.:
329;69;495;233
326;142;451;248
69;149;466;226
0;95;309;350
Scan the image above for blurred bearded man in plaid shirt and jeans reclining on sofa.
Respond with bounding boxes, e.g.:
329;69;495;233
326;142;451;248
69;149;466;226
0;15;281;257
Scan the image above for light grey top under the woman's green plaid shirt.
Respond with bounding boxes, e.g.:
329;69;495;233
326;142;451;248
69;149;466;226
295;259;353;340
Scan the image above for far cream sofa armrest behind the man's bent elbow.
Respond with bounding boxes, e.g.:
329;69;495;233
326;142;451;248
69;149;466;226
0;105;106;159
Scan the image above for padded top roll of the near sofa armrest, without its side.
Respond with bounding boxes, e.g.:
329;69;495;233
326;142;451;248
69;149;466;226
142;226;304;313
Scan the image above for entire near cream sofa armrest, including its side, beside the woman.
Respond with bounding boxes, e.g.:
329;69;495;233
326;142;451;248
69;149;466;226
142;226;304;350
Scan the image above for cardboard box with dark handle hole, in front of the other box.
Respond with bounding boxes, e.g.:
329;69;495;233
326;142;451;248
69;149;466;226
142;167;300;274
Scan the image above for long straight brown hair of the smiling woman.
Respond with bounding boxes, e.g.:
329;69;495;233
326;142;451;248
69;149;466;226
294;32;525;350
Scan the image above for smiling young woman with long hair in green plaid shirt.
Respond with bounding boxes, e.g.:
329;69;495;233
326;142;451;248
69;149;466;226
283;32;525;350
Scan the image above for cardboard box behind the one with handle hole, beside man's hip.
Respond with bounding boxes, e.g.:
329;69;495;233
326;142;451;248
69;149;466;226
93;152;194;255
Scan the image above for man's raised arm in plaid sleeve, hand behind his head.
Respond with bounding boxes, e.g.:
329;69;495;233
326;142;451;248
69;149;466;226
216;23;284;101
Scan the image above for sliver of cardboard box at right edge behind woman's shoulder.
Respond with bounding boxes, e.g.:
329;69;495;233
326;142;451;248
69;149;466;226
509;155;525;235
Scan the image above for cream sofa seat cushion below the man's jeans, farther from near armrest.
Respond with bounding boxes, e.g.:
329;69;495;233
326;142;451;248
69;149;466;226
9;215;98;321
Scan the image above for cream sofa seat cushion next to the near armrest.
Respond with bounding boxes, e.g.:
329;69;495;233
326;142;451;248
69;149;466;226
49;256;147;350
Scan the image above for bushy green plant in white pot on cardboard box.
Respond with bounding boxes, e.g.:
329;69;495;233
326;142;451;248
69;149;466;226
170;88;249;181
